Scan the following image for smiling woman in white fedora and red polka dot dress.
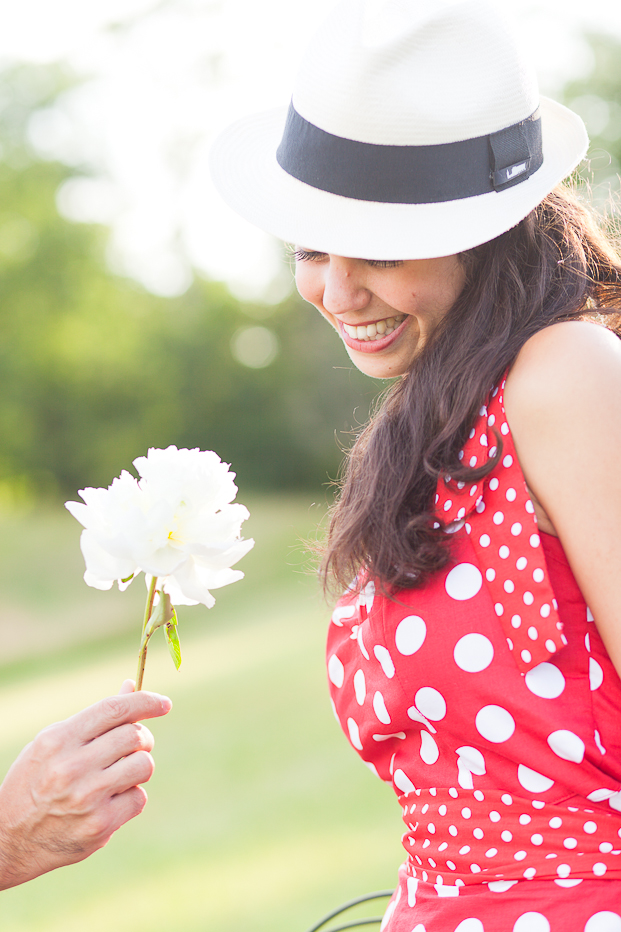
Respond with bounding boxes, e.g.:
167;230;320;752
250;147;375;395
212;0;621;932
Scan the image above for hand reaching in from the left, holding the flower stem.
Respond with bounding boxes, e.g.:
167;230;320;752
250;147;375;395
0;680;172;890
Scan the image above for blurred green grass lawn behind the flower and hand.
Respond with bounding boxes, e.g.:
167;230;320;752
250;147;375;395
0;496;402;932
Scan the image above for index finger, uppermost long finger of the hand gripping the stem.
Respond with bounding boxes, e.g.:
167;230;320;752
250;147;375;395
67;690;172;744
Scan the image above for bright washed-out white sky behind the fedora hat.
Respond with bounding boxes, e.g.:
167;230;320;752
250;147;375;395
0;0;621;300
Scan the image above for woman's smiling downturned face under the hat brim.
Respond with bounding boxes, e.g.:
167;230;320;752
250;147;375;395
295;248;465;379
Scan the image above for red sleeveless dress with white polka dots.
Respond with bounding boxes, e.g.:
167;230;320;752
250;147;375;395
328;382;621;932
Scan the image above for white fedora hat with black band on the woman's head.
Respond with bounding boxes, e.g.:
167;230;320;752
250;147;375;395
210;0;588;259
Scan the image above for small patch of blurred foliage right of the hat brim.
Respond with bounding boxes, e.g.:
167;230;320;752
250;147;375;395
563;34;621;209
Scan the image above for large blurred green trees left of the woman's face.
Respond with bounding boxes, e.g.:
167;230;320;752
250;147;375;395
0;67;382;496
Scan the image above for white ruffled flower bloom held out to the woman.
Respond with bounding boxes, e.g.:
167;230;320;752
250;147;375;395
66;446;254;608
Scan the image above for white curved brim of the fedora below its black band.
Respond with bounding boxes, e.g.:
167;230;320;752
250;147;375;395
210;97;588;259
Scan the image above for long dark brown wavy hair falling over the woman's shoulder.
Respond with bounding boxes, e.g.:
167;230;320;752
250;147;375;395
321;187;621;591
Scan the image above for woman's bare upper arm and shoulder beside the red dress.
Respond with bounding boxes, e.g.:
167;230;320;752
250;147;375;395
505;321;621;676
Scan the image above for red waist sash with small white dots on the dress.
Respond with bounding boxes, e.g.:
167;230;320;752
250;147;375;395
399;787;621;889
